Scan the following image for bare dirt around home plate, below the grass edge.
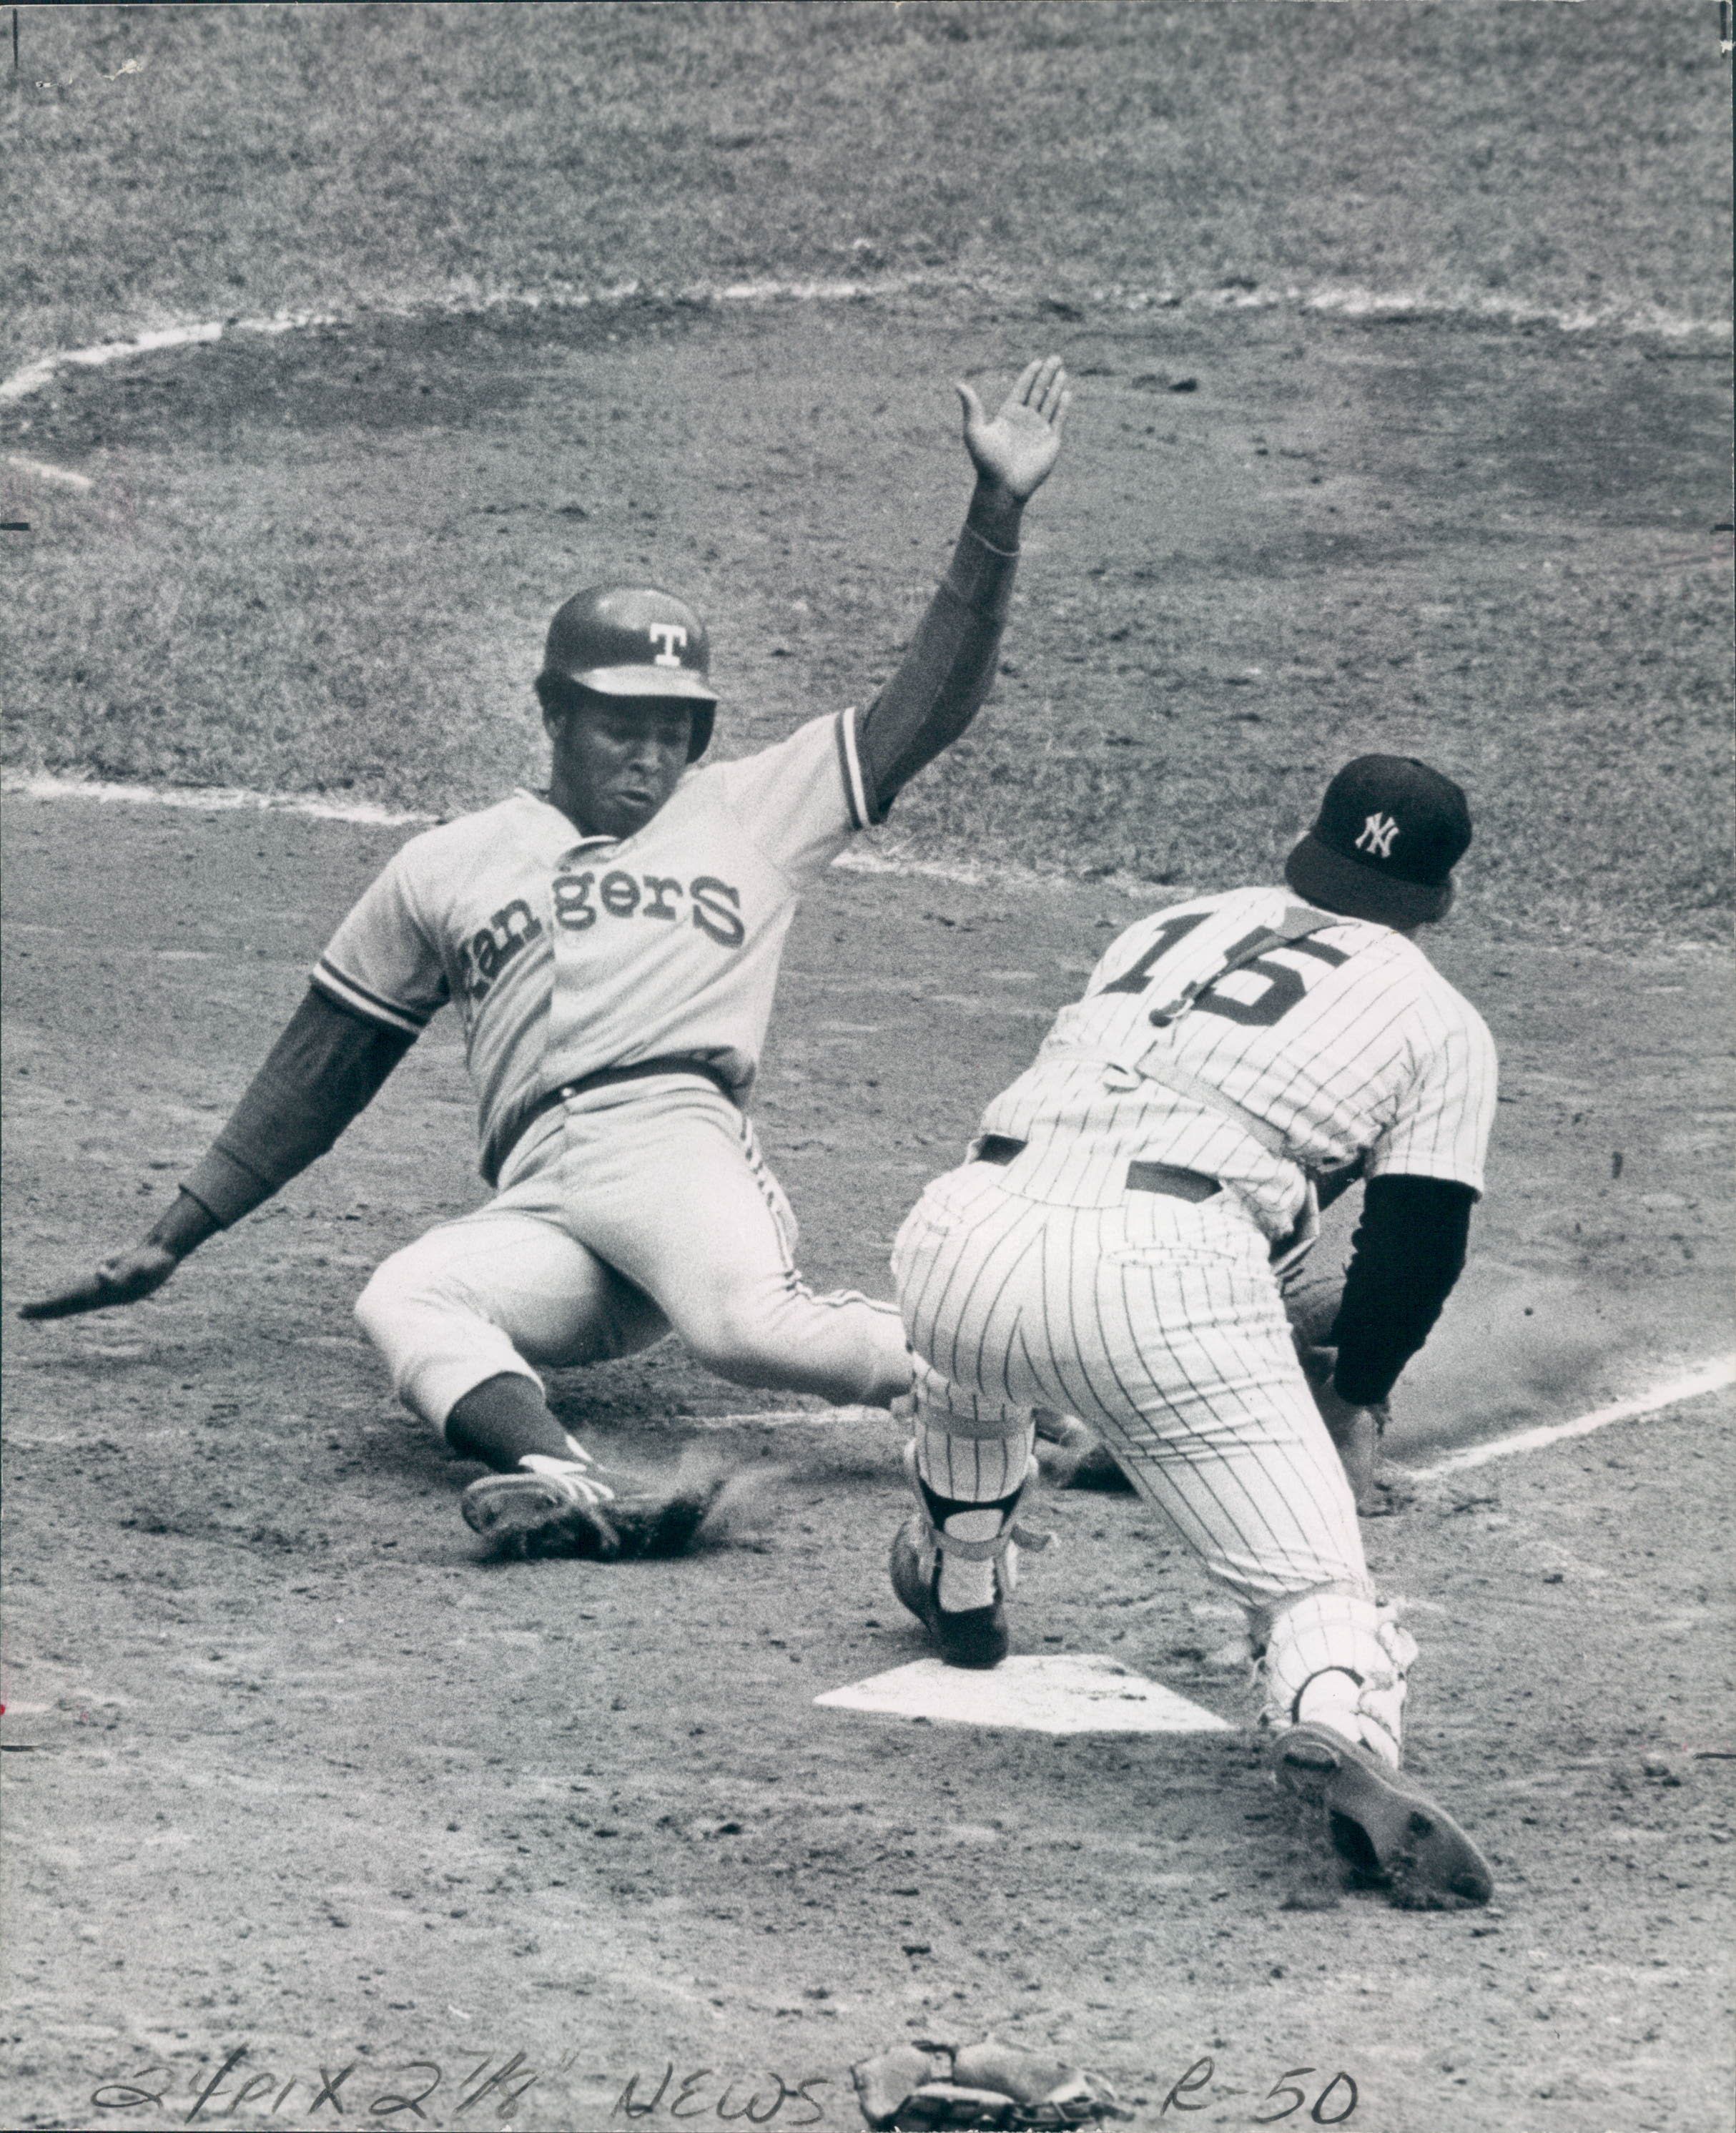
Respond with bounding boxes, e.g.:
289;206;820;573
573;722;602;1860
4;800;1736;2133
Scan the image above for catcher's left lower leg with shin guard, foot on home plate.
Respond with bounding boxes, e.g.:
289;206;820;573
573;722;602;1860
892;1359;1047;1668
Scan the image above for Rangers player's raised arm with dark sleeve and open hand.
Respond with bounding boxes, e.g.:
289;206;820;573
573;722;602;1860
859;356;1072;815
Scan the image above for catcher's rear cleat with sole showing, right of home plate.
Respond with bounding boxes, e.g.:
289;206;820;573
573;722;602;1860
1271;1725;1495;1911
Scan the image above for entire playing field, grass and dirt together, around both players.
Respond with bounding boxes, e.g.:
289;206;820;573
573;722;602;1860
0;0;1736;2099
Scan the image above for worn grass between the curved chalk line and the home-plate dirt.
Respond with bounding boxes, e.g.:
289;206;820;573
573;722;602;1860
6;305;1730;941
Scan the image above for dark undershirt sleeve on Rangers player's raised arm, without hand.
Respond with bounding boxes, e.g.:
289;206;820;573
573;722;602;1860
857;525;1017;821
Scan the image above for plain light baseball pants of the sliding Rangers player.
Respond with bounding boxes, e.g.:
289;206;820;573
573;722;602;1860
356;1077;911;1427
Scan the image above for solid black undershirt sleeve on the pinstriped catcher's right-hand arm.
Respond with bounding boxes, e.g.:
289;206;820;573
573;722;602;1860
1331;1178;1476;1408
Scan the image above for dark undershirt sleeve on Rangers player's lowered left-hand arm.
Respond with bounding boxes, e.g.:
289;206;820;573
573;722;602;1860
182;987;416;1228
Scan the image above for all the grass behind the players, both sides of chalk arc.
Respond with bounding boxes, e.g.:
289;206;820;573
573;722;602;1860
0;0;1730;937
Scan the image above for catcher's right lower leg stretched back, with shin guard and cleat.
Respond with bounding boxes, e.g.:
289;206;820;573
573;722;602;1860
1254;1589;1495;1907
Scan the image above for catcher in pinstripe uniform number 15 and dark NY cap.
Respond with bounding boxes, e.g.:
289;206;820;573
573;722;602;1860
894;755;1495;1903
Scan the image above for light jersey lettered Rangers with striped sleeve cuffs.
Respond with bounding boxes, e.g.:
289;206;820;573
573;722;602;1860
313;710;870;1148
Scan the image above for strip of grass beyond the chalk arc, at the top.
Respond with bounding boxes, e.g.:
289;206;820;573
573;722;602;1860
0;0;1730;360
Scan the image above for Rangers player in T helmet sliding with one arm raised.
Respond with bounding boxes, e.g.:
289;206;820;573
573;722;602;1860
24;356;1070;1557
